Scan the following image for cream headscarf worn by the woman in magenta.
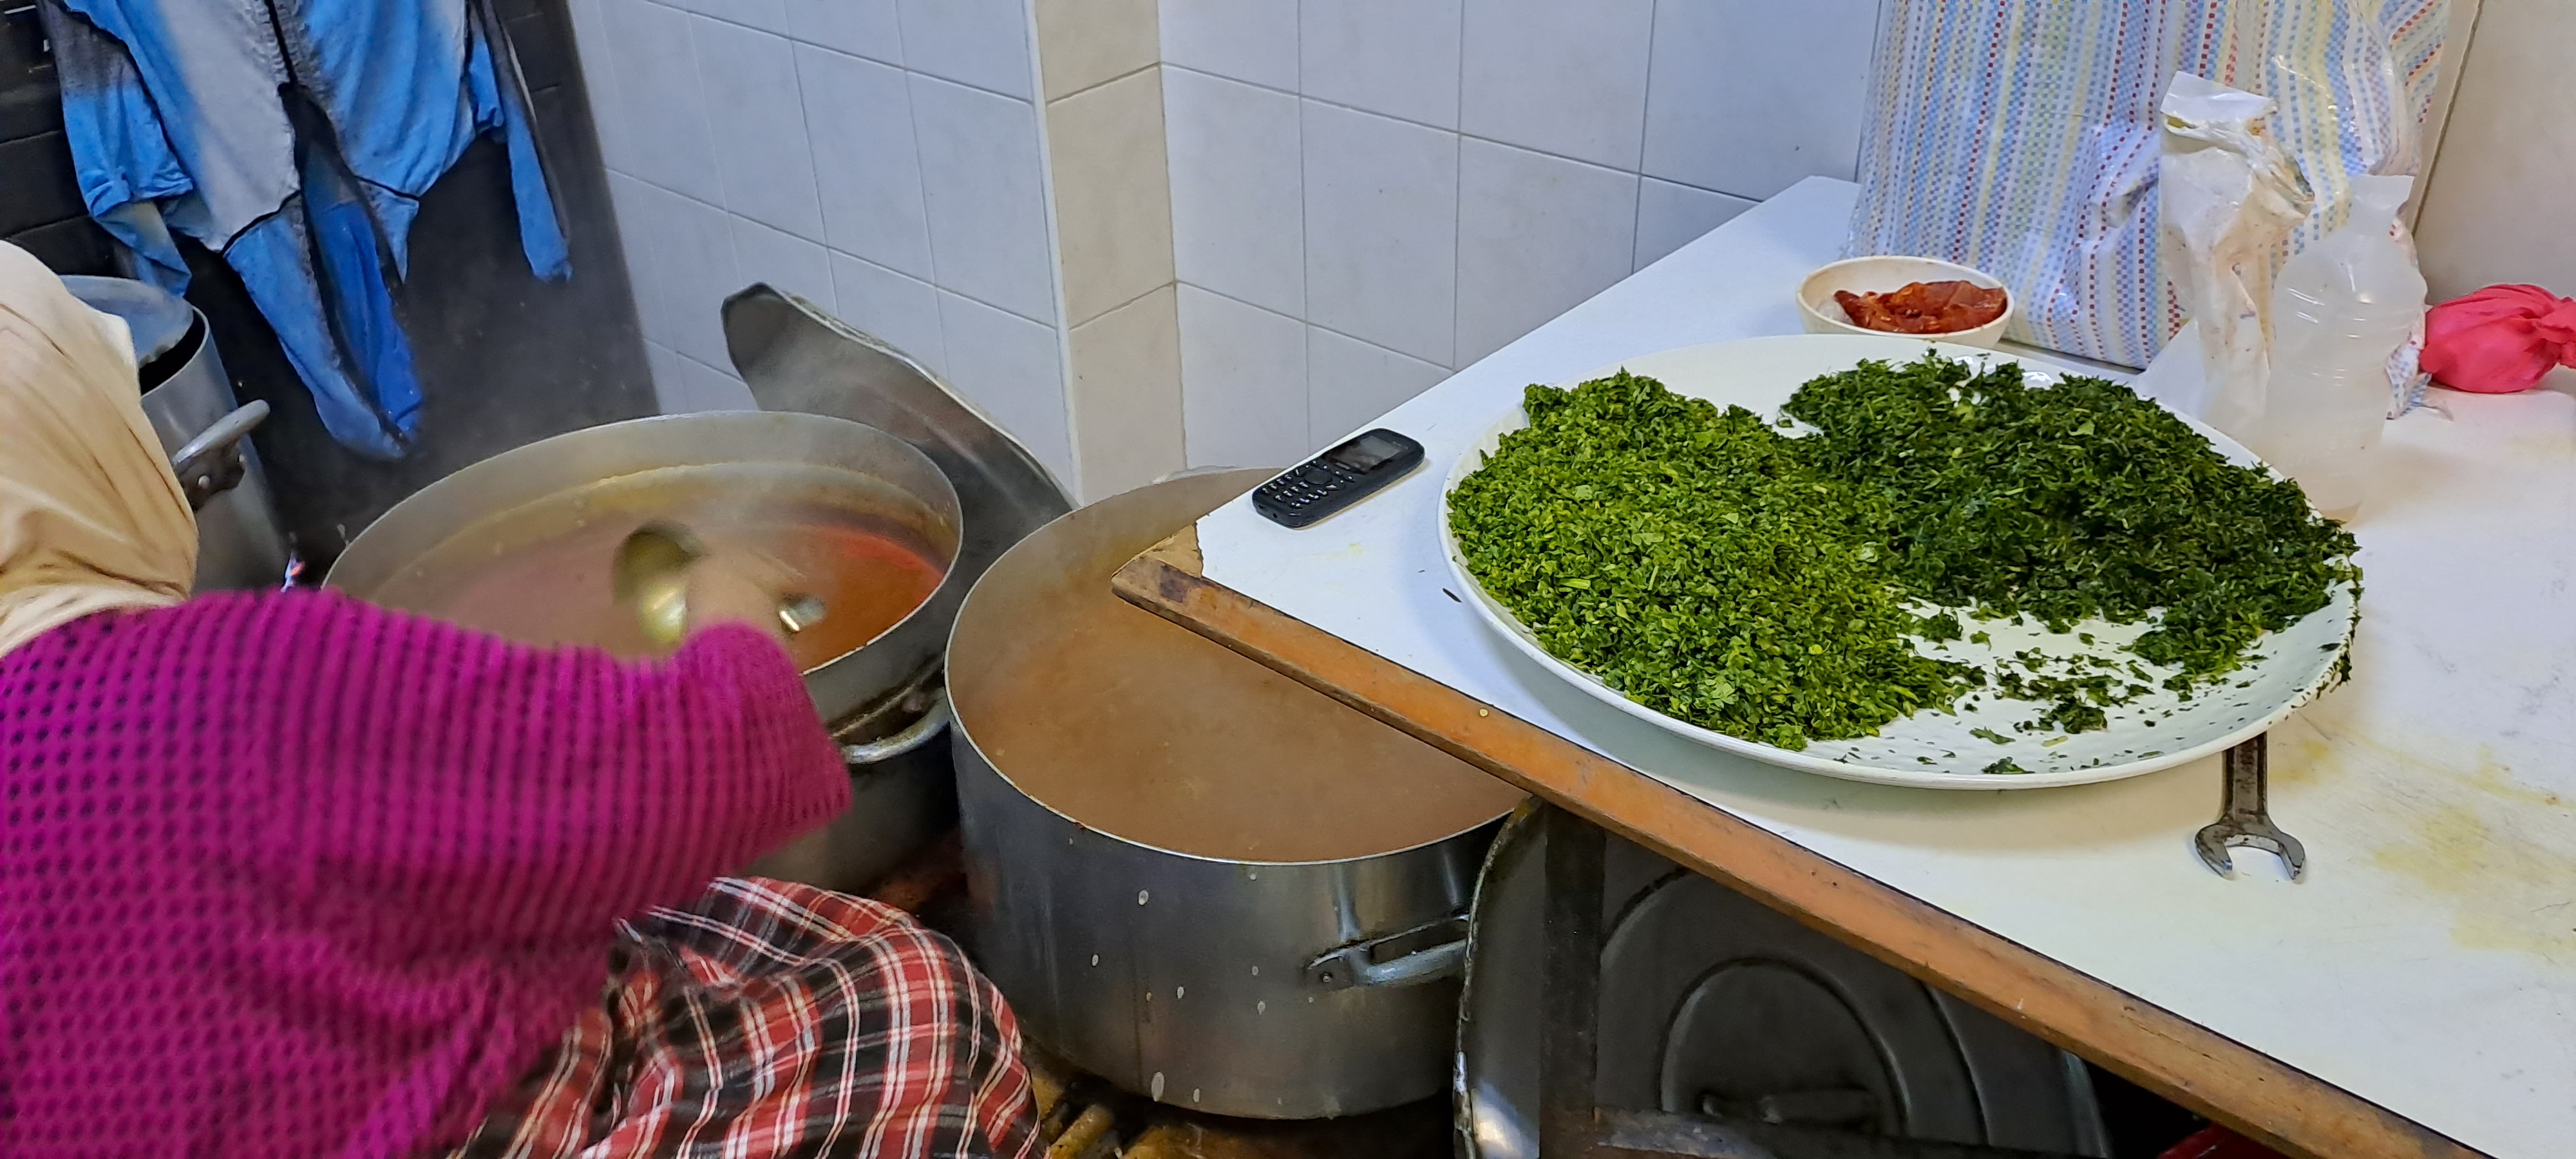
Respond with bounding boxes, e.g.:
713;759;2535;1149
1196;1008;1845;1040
0;242;196;654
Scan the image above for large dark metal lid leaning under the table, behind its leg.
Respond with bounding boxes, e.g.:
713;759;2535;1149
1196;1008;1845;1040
1458;809;2110;1159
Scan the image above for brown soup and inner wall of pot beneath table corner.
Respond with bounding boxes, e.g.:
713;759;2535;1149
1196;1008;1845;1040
948;469;1522;865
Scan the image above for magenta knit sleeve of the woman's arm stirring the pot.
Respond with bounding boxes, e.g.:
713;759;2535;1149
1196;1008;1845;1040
252;595;850;945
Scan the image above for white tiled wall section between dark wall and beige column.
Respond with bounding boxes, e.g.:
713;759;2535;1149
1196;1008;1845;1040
572;0;1077;484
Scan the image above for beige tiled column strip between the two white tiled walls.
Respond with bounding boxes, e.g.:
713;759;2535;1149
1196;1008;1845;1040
1036;0;1185;500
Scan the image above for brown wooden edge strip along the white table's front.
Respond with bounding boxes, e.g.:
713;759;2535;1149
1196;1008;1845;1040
1113;543;2478;1159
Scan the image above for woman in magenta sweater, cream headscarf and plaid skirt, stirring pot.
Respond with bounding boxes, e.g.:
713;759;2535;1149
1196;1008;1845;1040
0;242;1036;1159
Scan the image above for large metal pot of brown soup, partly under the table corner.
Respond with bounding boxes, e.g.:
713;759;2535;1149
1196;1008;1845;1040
948;471;1520;1118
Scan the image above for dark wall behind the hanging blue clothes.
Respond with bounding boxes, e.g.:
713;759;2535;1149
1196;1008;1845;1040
0;0;654;561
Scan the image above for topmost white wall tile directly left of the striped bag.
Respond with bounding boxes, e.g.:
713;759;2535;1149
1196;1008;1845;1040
1643;0;1878;201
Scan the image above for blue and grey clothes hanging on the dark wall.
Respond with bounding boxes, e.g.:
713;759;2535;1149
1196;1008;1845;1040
41;0;572;458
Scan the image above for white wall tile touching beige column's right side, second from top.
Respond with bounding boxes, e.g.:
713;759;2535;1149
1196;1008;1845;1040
1162;67;1306;314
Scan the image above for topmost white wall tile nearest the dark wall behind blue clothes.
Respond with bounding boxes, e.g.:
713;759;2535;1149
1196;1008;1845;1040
600;0;724;203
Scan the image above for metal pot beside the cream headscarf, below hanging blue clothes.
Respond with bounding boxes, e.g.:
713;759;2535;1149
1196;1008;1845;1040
62;276;286;592
